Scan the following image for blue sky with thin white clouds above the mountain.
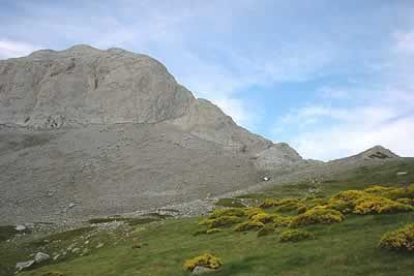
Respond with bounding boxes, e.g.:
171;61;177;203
0;0;414;160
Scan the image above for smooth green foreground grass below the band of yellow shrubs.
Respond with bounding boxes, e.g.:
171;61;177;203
17;214;414;276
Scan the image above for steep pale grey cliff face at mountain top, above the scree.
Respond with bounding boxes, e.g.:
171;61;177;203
0;46;194;128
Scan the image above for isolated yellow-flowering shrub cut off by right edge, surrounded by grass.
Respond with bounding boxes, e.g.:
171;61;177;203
380;223;414;251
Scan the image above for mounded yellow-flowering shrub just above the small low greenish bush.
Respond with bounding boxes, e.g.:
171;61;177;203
289;206;344;228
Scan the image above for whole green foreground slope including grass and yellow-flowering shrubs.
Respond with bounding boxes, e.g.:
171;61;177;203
0;160;414;276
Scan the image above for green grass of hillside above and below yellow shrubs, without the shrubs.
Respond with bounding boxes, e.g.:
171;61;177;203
0;160;414;276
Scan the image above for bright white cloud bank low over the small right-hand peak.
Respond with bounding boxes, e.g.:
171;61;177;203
274;91;414;161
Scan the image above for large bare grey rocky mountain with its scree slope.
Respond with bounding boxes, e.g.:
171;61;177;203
0;45;302;223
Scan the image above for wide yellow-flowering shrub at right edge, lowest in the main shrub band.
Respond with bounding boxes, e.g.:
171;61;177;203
354;195;413;215
